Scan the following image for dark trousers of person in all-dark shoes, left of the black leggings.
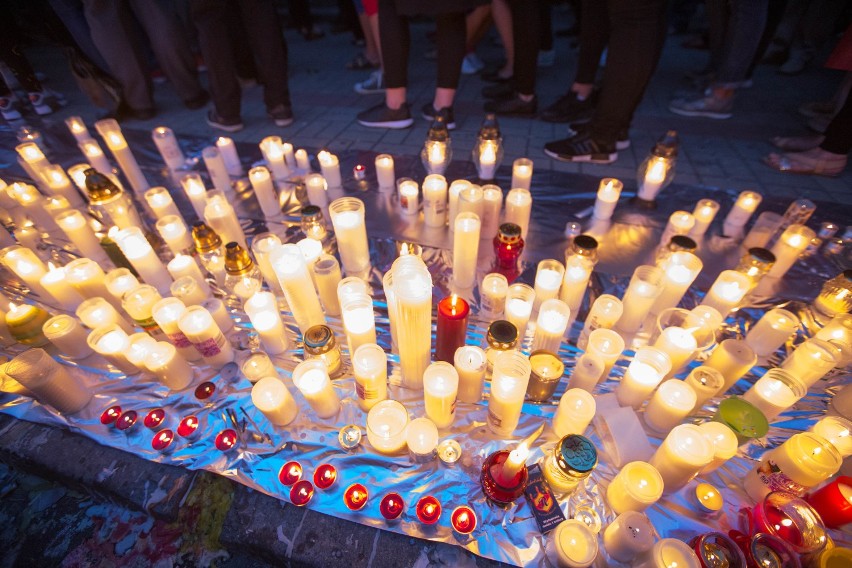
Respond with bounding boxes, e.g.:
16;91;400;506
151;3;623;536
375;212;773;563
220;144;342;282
189;0;290;119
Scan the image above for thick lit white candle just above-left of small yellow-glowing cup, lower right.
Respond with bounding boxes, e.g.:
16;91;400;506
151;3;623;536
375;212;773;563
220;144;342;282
649;424;715;494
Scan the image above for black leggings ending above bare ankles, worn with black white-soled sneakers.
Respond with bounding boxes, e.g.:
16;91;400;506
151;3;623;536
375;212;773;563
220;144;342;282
379;0;466;89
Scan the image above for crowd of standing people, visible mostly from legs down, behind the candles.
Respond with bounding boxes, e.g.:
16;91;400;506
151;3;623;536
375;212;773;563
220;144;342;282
0;0;852;175
